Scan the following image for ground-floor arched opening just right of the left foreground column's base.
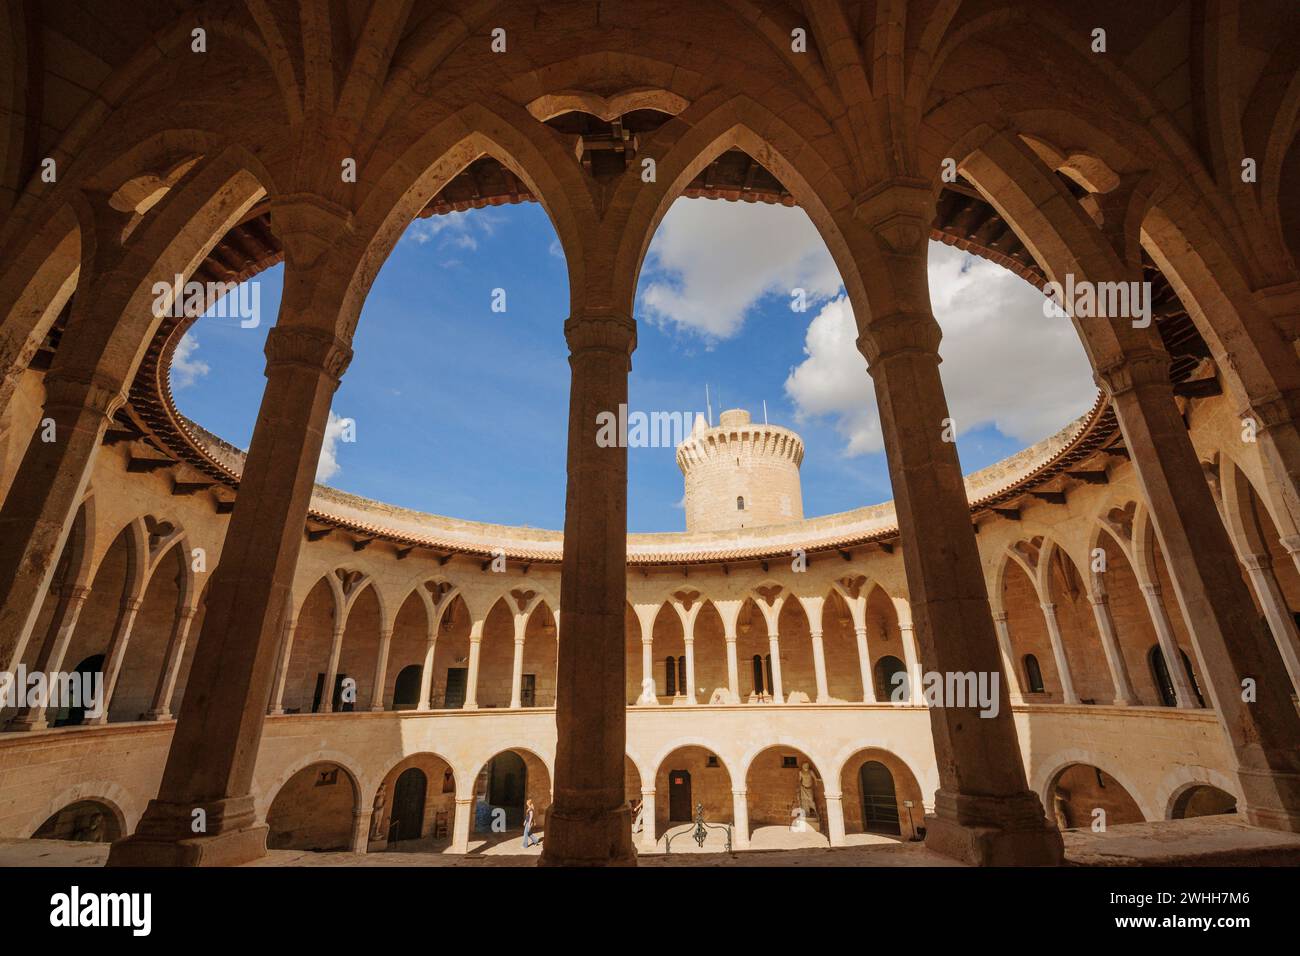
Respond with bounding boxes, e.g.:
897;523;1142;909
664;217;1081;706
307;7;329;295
267;762;356;852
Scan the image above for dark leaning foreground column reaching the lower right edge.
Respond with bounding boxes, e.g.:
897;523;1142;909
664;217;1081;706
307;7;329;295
1097;351;1300;832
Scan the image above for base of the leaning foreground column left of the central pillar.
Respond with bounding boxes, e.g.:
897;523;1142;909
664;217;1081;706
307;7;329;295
107;797;270;866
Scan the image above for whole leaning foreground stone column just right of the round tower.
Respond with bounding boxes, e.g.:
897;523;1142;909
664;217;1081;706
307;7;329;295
854;178;1063;865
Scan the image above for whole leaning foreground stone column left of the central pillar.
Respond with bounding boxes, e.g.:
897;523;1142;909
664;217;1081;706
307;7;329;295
108;267;351;866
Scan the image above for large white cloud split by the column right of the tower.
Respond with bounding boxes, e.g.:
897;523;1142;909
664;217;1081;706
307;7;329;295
785;243;1097;455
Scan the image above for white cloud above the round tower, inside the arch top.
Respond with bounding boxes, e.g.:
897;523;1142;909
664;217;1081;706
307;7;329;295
641;199;841;339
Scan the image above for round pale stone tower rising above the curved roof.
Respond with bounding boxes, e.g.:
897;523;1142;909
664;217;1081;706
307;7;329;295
677;408;803;531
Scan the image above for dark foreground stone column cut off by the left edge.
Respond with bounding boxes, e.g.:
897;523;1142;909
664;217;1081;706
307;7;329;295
0;369;122;671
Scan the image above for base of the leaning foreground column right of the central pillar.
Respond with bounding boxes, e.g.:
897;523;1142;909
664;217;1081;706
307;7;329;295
926;790;1065;866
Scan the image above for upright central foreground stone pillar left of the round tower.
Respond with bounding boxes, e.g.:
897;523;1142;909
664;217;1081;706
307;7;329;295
541;312;636;865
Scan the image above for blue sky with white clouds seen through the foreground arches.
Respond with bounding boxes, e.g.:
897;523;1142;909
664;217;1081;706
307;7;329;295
173;199;1096;531
